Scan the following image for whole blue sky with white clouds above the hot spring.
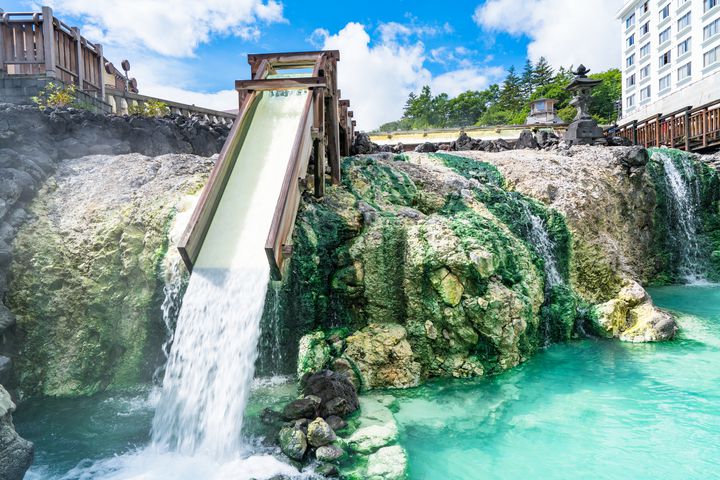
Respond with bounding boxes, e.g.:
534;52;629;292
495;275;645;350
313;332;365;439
2;0;622;128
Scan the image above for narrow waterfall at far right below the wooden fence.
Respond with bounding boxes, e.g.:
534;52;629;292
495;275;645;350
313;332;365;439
654;152;705;283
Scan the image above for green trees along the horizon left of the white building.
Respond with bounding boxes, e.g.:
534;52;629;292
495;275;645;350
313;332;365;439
378;58;622;131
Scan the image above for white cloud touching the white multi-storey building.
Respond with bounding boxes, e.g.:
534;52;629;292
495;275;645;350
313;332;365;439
473;0;623;72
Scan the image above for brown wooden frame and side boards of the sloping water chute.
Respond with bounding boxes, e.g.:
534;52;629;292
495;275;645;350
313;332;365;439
178;50;346;280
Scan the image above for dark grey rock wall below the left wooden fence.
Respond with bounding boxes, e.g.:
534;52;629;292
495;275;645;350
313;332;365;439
0;104;229;384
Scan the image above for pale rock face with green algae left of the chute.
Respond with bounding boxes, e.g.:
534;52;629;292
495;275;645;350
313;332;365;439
9;154;211;396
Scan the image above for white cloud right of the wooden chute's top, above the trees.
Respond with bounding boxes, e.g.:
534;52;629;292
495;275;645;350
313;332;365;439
318;23;502;129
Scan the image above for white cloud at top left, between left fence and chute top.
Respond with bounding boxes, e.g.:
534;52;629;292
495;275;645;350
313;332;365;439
44;0;285;57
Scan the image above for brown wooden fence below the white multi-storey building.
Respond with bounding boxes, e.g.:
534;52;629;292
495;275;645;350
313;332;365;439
616;100;720;152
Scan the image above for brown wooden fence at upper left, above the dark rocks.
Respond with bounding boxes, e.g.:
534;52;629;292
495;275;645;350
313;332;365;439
0;7;105;98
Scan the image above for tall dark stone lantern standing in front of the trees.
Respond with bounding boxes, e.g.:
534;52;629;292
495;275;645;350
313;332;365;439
565;65;603;145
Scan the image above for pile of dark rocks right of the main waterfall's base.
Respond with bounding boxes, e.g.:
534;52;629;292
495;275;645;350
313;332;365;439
262;370;360;476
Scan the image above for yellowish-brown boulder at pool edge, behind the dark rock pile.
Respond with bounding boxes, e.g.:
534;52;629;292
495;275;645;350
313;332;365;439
345;324;421;388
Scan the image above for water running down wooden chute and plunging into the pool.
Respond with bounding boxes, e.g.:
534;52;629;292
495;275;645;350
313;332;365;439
152;91;307;461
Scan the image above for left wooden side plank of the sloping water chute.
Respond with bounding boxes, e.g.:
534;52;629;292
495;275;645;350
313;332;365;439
178;94;258;271
